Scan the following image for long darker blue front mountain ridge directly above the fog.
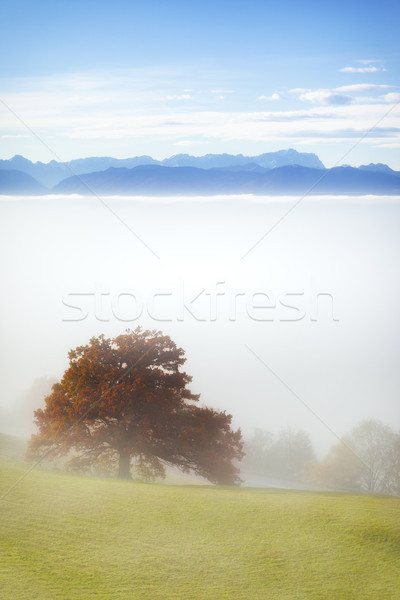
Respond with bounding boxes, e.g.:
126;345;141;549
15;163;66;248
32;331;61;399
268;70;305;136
53;165;400;196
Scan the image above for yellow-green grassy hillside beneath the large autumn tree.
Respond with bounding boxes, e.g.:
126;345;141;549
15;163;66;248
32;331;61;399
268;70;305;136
0;459;400;600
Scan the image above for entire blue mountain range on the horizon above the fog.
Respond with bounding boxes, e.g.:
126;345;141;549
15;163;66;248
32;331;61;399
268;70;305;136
0;150;400;195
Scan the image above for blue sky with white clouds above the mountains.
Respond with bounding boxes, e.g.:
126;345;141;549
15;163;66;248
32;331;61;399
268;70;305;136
0;0;400;169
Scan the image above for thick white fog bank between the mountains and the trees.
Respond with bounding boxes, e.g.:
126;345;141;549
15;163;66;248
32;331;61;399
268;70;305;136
0;196;400;451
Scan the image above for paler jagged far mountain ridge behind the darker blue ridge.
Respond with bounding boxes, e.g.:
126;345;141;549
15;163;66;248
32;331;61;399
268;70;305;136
0;149;324;188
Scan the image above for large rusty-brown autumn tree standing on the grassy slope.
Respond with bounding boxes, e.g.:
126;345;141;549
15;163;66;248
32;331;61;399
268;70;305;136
28;328;243;484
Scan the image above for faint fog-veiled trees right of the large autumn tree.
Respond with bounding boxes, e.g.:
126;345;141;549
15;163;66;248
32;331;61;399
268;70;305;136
242;419;400;495
